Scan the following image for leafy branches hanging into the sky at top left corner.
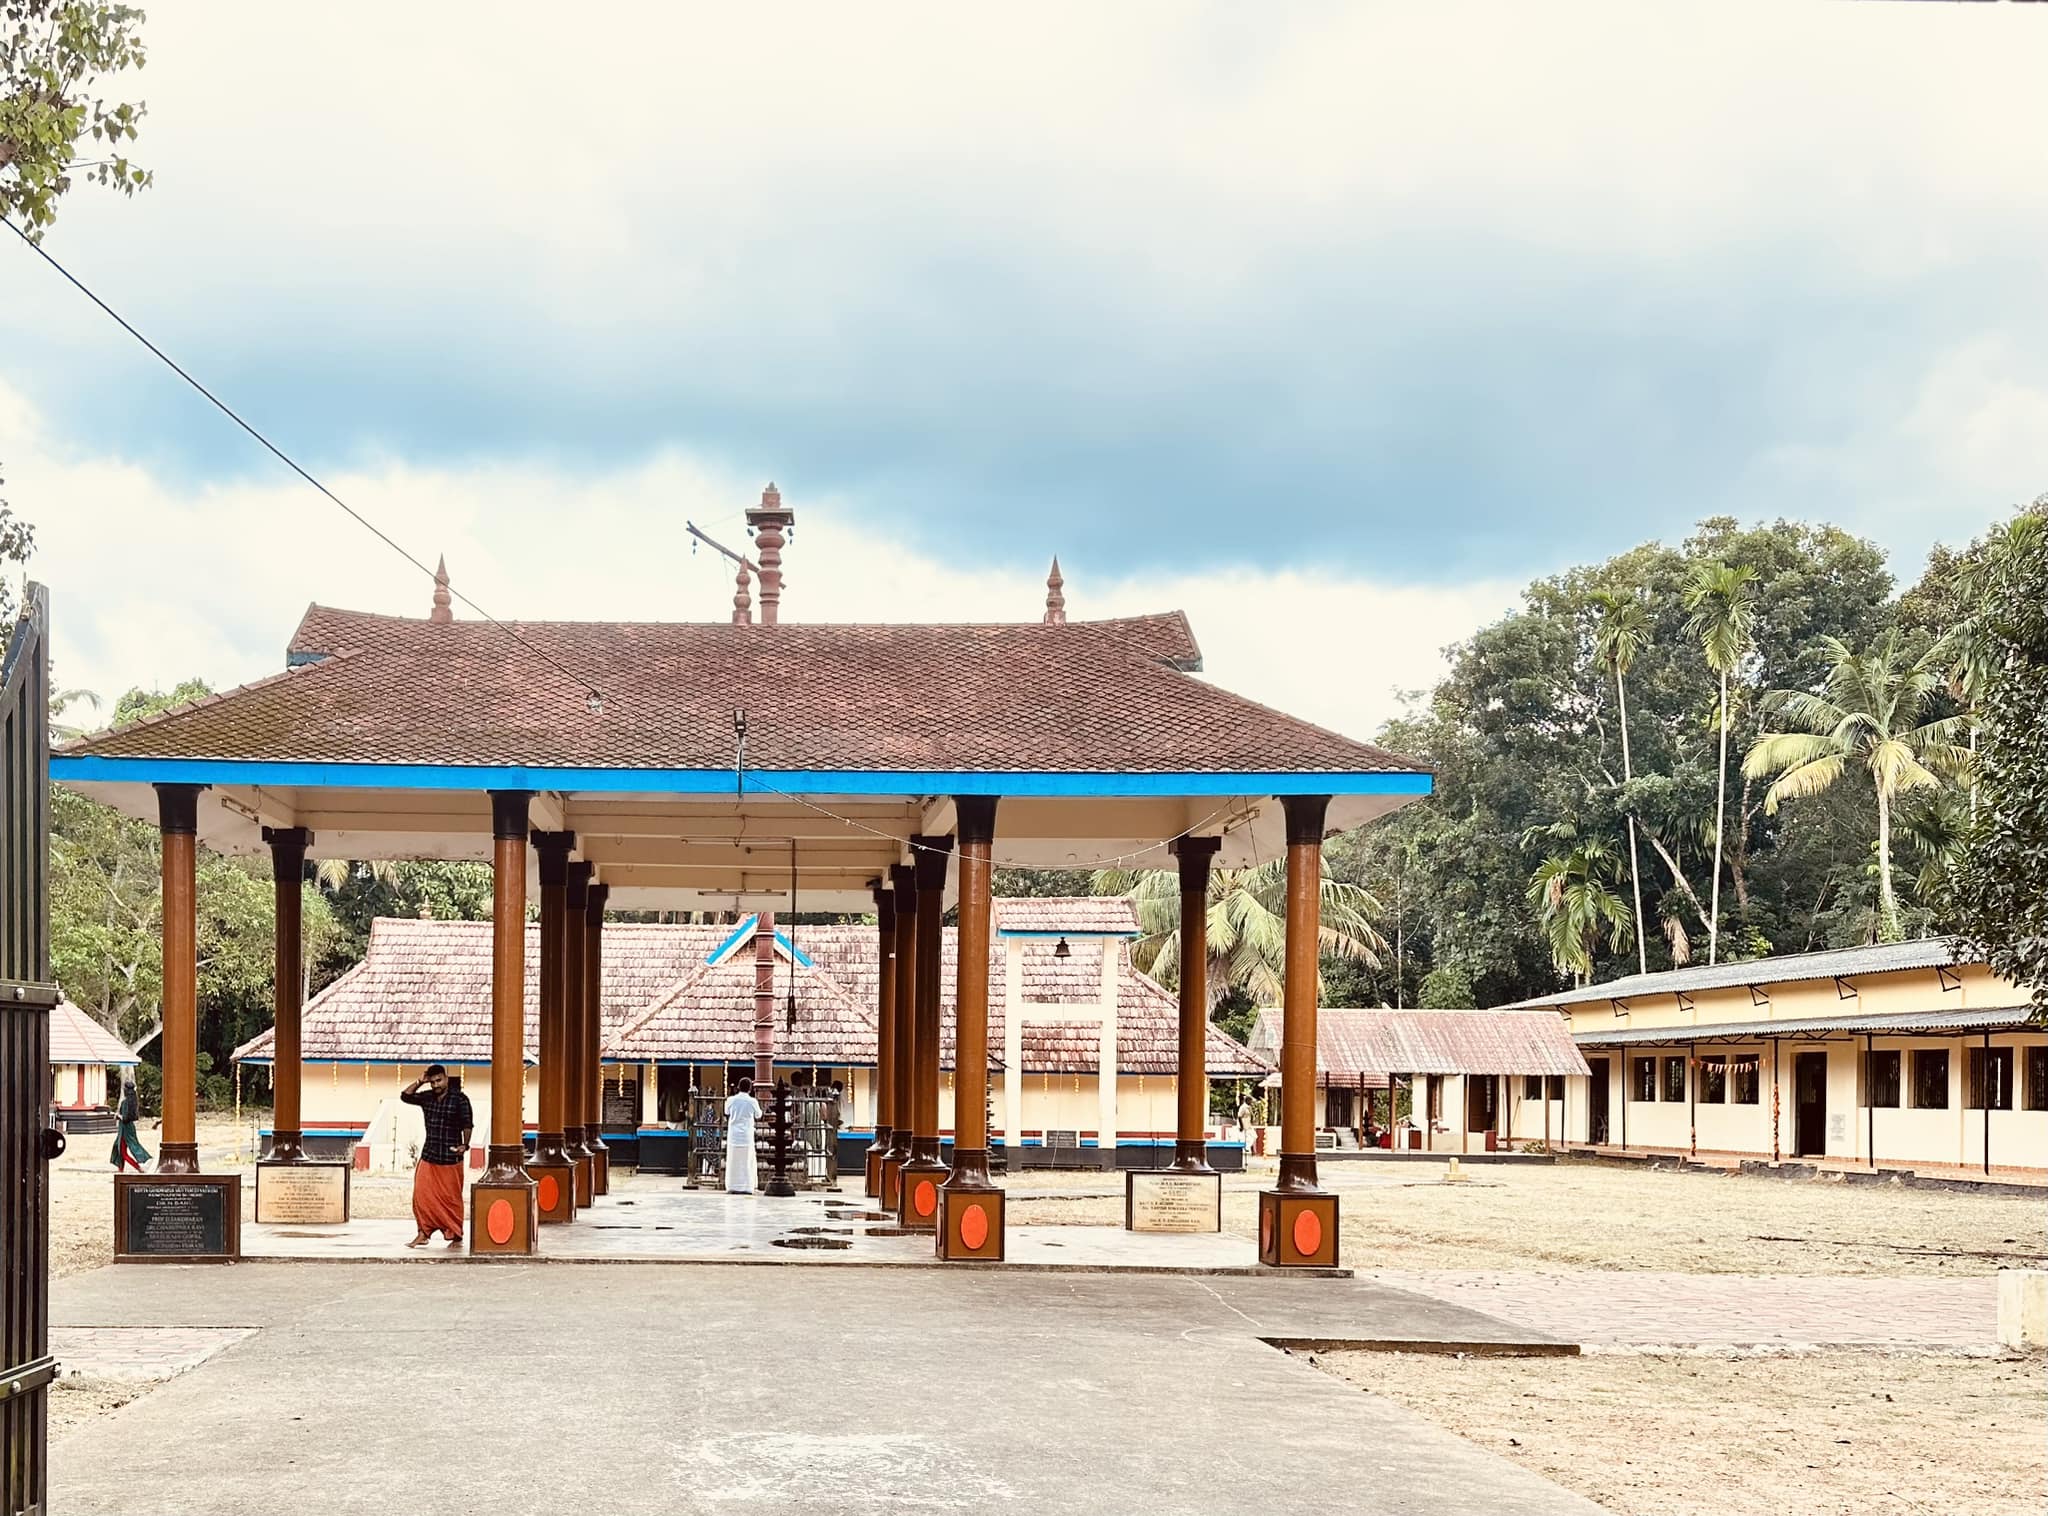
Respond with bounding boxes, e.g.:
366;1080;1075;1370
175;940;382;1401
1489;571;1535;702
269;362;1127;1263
0;0;154;242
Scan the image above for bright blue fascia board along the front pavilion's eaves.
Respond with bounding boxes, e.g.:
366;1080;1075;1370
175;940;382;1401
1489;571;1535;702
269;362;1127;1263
49;754;1432;799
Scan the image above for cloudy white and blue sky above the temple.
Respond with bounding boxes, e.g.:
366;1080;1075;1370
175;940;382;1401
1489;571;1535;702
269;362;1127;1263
0;0;2048;735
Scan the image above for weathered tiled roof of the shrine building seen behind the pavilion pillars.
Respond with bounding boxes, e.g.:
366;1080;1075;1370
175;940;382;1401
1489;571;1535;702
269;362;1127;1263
236;918;1266;1078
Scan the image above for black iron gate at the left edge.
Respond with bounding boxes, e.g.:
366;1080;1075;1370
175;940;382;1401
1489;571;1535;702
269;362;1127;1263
0;584;59;1516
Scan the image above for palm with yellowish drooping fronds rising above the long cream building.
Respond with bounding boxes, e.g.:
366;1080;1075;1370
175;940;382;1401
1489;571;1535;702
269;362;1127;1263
1743;629;1970;940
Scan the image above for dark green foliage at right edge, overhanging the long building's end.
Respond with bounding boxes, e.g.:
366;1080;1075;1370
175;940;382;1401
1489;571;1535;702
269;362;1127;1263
1952;498;2048;1020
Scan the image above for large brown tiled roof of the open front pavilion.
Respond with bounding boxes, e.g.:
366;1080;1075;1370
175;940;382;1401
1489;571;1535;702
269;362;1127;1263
59;606;1415;774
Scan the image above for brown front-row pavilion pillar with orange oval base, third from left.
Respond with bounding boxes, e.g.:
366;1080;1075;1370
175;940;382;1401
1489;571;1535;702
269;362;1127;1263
932;795;1003;1260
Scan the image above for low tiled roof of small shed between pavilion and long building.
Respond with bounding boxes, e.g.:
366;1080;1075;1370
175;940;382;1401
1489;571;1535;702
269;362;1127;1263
1251;1008;1587;1090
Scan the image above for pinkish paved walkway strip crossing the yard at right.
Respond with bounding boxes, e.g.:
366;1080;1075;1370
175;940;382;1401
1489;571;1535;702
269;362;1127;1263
1362;1270;1999;1350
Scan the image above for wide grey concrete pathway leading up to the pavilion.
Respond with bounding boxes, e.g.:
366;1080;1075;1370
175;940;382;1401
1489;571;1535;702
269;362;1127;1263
51;1264;1597;1516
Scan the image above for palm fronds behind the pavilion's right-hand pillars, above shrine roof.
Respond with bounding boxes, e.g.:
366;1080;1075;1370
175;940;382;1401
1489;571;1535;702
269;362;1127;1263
1092;858;1386;1014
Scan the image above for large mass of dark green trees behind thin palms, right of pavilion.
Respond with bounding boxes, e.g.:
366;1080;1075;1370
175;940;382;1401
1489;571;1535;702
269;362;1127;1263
1327;518;1925;1006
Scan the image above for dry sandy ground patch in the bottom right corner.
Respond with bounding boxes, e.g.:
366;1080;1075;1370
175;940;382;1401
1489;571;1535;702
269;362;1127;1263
1315;1352;2048;1516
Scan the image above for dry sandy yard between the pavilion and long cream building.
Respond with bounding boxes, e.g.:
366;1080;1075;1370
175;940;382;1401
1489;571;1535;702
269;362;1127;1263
1010;1164;2048;1276
